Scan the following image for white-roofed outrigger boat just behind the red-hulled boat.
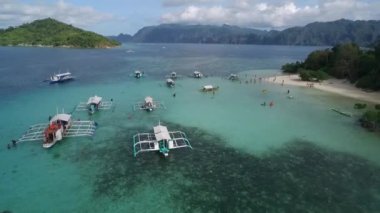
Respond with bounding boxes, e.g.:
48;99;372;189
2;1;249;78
75;95;113;114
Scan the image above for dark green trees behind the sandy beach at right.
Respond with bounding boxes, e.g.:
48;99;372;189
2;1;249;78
282;42;380;90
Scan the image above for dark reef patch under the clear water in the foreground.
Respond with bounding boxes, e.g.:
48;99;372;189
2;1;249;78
72;124;380;213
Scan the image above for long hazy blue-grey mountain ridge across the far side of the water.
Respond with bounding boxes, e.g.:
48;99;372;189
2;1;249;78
112;19;380;46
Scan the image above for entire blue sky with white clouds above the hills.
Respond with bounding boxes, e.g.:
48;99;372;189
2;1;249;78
0;0;380;35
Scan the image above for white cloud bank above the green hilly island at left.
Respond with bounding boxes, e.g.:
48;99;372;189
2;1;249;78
0;0;113;28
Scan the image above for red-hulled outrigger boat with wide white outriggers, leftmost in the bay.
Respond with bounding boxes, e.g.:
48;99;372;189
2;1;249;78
16;113;96;148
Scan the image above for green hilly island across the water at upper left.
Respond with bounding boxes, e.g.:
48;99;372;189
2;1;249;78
0;18;120;48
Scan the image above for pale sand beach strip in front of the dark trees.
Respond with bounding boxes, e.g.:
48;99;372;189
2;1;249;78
265;74;380;104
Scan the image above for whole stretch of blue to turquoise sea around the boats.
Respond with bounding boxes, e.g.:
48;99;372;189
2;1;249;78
0;44;380;212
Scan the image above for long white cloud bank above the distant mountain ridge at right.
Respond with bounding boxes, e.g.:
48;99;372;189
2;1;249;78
161;0;380;29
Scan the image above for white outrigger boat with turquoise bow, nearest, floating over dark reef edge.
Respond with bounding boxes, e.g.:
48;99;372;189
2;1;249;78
133;123;192;157
